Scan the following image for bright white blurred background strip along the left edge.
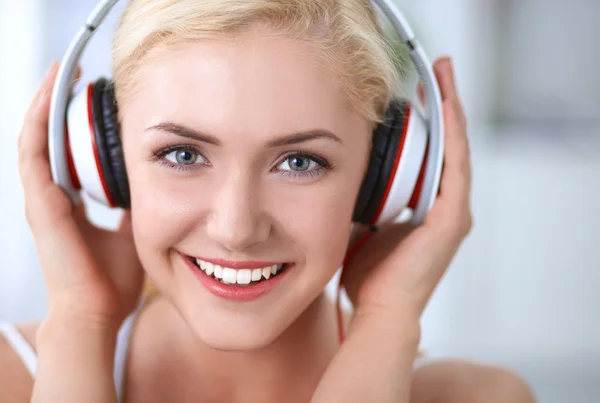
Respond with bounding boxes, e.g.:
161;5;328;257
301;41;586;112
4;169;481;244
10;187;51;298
0;0;45;319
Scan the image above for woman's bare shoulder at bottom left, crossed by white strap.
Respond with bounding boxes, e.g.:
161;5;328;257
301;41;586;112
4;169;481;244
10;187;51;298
0;324;38;403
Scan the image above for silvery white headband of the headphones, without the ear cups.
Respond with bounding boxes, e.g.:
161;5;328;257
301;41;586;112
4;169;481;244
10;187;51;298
48;0;444;223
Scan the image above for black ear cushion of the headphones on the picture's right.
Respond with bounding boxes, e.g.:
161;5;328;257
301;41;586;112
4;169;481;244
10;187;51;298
353;102;408;225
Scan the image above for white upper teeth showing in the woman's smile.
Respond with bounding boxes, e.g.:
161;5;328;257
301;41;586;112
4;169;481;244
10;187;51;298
194;259;284;286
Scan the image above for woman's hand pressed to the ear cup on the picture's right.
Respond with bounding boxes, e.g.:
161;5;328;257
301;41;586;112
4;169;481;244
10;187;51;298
343;58;472;321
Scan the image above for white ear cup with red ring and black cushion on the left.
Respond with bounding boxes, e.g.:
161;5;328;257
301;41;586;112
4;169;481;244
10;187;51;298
67;78;130;208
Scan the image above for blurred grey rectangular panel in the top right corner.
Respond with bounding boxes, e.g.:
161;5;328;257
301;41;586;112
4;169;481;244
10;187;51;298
499;0;600;124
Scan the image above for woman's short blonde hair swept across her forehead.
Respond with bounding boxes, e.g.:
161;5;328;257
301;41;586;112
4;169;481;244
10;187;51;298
112;0;406;123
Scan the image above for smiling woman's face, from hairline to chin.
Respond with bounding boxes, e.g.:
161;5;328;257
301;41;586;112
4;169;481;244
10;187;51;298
120;27;371;350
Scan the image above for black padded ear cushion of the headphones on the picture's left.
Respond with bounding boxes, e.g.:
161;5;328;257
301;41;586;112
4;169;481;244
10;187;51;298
92;78;130;208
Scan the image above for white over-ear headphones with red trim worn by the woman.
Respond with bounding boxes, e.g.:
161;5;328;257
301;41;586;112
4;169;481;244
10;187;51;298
48;0;444;226
